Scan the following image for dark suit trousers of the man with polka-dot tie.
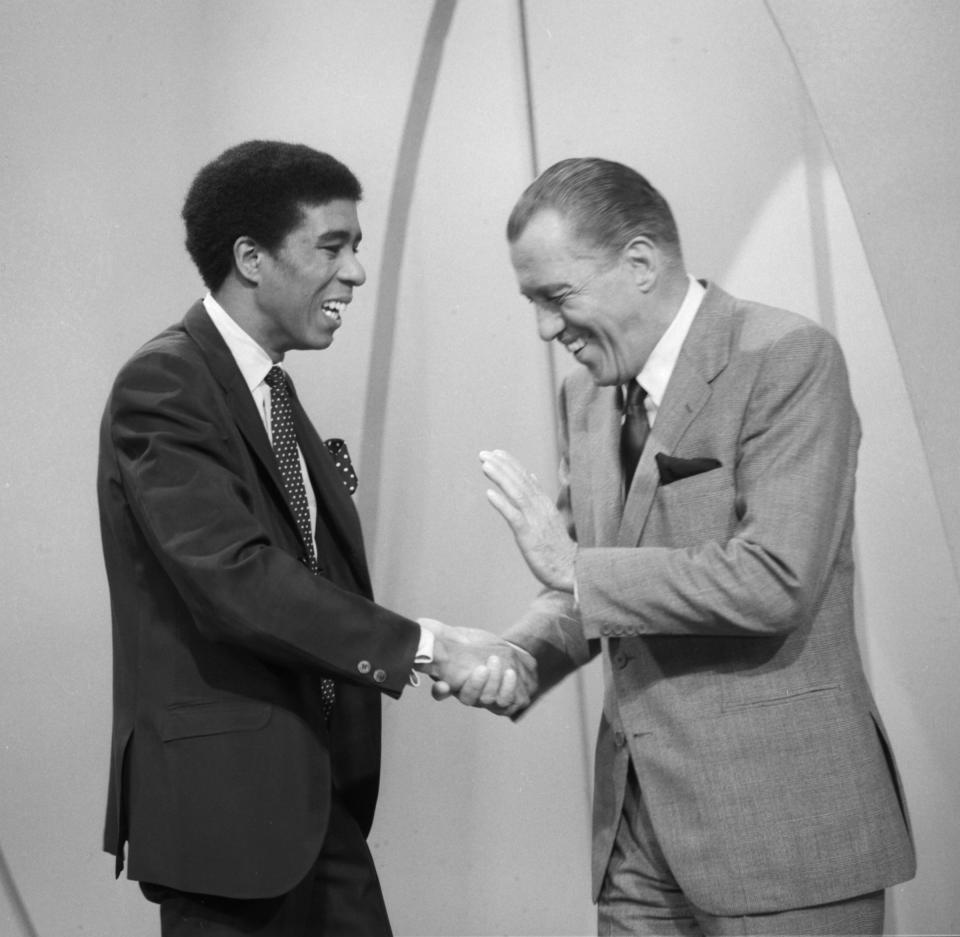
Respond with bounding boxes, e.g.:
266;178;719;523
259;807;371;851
140;796;393;937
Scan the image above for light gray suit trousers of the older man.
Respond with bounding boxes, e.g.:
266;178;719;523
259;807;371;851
597;764;884;937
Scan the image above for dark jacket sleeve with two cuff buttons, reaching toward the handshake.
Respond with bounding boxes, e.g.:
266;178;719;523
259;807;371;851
105;351;420;696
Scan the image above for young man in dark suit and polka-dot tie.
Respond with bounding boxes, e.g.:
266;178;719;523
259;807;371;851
98;141;528;937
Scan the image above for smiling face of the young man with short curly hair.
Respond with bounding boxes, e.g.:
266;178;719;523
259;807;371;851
248;199;367;361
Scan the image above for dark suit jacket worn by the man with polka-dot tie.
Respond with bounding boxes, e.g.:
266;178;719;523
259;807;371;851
98;303;420;898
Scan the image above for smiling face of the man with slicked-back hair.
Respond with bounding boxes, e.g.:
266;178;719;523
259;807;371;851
510;209;669;385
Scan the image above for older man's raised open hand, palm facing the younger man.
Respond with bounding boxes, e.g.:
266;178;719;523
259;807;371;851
480;449;577;592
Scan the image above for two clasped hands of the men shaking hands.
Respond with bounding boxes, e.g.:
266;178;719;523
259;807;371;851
416;618;537;716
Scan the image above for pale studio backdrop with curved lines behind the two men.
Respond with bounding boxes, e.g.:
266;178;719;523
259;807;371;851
0;0;960;937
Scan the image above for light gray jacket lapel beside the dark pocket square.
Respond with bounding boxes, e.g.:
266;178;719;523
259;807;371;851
617;285;733;547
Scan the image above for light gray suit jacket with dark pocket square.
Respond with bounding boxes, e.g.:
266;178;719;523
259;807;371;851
508;285;915;915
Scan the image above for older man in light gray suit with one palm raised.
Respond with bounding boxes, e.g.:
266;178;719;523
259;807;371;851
439;159;914;935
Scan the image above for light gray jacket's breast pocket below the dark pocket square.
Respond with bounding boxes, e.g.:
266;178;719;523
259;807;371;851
648;467;737;547
